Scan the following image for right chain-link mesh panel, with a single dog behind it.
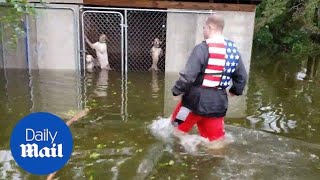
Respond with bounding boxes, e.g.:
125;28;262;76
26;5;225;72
127;10;167;72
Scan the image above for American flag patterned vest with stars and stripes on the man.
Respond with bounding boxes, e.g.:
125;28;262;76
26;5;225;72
202;36;240;89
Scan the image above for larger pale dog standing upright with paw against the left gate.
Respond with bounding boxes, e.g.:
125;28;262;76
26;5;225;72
85;34;111;70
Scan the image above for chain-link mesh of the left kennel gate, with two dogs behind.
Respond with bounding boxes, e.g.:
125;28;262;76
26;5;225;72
82;10;123;71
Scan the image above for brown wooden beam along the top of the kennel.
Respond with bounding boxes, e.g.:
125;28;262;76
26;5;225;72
83;0;256;12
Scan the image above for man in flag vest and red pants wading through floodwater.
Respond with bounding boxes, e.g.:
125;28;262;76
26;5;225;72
172;14;247;141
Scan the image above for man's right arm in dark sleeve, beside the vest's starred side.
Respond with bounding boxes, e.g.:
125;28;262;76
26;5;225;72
229;57;248;96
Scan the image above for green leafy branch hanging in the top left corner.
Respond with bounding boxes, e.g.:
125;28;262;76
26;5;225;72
0;0;43;48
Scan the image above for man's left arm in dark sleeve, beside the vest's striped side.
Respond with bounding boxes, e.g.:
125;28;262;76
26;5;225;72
171;45;204;96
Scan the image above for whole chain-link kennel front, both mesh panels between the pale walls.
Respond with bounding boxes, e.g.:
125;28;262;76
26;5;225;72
82;8;167;72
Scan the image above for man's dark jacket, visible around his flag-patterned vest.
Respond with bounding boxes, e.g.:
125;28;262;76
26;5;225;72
172;41;247;117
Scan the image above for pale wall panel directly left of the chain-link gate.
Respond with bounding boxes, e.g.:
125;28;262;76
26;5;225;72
29;5;80;70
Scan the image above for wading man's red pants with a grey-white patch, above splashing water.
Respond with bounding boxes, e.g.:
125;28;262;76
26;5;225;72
172;102;225;141
